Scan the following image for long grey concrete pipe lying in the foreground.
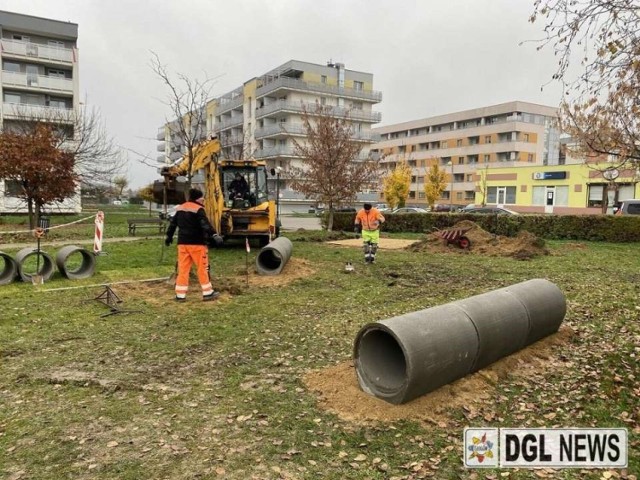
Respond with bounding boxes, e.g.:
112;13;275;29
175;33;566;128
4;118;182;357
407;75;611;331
354;279;566;404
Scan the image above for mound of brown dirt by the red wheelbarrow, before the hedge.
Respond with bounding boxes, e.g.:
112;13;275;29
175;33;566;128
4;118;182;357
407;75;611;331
408;220;549;260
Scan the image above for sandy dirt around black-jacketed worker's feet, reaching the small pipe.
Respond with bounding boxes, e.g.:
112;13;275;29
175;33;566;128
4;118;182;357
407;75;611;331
124;258;315;306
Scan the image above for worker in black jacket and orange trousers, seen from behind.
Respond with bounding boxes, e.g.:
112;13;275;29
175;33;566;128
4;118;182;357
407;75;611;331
165;188;219;301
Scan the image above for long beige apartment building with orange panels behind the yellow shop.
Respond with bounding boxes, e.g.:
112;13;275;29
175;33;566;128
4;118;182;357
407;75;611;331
371;101;564;206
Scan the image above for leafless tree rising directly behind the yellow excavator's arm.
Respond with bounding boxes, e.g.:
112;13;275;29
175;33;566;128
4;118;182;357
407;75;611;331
151;52;213;187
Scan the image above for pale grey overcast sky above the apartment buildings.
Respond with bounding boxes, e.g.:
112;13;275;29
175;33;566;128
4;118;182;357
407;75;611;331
5;0;561;188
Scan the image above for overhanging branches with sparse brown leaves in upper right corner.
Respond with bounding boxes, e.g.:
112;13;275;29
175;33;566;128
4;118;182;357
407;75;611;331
530;0;640;169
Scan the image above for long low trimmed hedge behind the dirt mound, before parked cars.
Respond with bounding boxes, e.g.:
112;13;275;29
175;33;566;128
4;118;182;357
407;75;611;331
321;213;640;243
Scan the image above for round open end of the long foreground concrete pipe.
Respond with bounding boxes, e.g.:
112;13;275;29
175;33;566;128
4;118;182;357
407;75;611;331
355;324;407;397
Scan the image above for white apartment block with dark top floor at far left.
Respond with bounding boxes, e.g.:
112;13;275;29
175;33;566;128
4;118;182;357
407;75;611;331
0;11;80;213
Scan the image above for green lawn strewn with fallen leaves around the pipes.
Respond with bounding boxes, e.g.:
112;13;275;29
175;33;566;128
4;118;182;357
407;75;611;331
0;216;640;479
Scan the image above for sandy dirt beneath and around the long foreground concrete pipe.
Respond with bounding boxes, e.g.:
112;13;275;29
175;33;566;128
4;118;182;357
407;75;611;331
304;326;573;428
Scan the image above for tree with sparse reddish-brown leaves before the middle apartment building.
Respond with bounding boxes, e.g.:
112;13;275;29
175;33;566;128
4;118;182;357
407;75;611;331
288;103;379;231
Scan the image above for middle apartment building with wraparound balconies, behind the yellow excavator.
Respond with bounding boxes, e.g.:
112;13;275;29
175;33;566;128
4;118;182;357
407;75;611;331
157;60;382;201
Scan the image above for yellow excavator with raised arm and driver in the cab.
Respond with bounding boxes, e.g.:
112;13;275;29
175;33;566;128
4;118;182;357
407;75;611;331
153;138;280;245
